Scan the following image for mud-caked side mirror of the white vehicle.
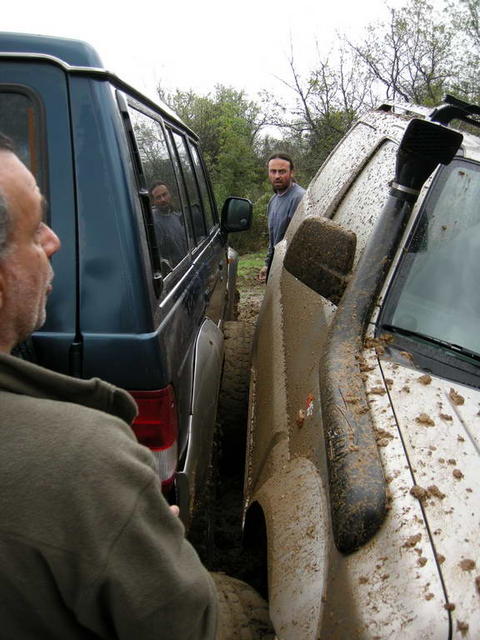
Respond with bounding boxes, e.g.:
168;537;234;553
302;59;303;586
283;217;357;304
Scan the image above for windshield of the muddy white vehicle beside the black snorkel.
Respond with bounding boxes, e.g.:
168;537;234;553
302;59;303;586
382;160;480;353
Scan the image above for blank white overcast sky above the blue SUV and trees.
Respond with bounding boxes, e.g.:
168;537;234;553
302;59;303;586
0;0;420;102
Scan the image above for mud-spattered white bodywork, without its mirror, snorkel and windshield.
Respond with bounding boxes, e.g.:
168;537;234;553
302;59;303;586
245;104;480;640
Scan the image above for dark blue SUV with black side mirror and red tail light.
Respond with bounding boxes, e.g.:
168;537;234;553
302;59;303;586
0;33;251;525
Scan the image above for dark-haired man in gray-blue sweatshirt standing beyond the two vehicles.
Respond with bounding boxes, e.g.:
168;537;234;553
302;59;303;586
258;153;305;281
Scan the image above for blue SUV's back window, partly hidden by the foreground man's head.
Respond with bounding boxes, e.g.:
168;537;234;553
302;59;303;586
0;87;45;192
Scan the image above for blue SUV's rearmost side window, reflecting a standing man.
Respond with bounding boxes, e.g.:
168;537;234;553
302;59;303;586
129;108;188;276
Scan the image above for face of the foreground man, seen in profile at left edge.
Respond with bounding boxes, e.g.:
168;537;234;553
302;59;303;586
0;151;60;352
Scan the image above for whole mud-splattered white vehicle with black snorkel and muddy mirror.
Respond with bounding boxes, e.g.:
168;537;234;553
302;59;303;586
245;99;480;640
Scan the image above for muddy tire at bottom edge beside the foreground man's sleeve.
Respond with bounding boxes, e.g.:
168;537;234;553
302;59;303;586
211;573;275;640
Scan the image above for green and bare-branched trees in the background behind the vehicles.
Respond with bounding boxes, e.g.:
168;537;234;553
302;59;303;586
159;0;480;253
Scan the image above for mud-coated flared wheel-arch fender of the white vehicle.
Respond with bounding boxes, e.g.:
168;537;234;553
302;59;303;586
246;456;332;640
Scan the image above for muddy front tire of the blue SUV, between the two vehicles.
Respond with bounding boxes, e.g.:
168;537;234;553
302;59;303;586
217;322;254;467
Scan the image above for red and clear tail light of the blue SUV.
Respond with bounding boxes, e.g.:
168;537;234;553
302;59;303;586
130;385;178;492
